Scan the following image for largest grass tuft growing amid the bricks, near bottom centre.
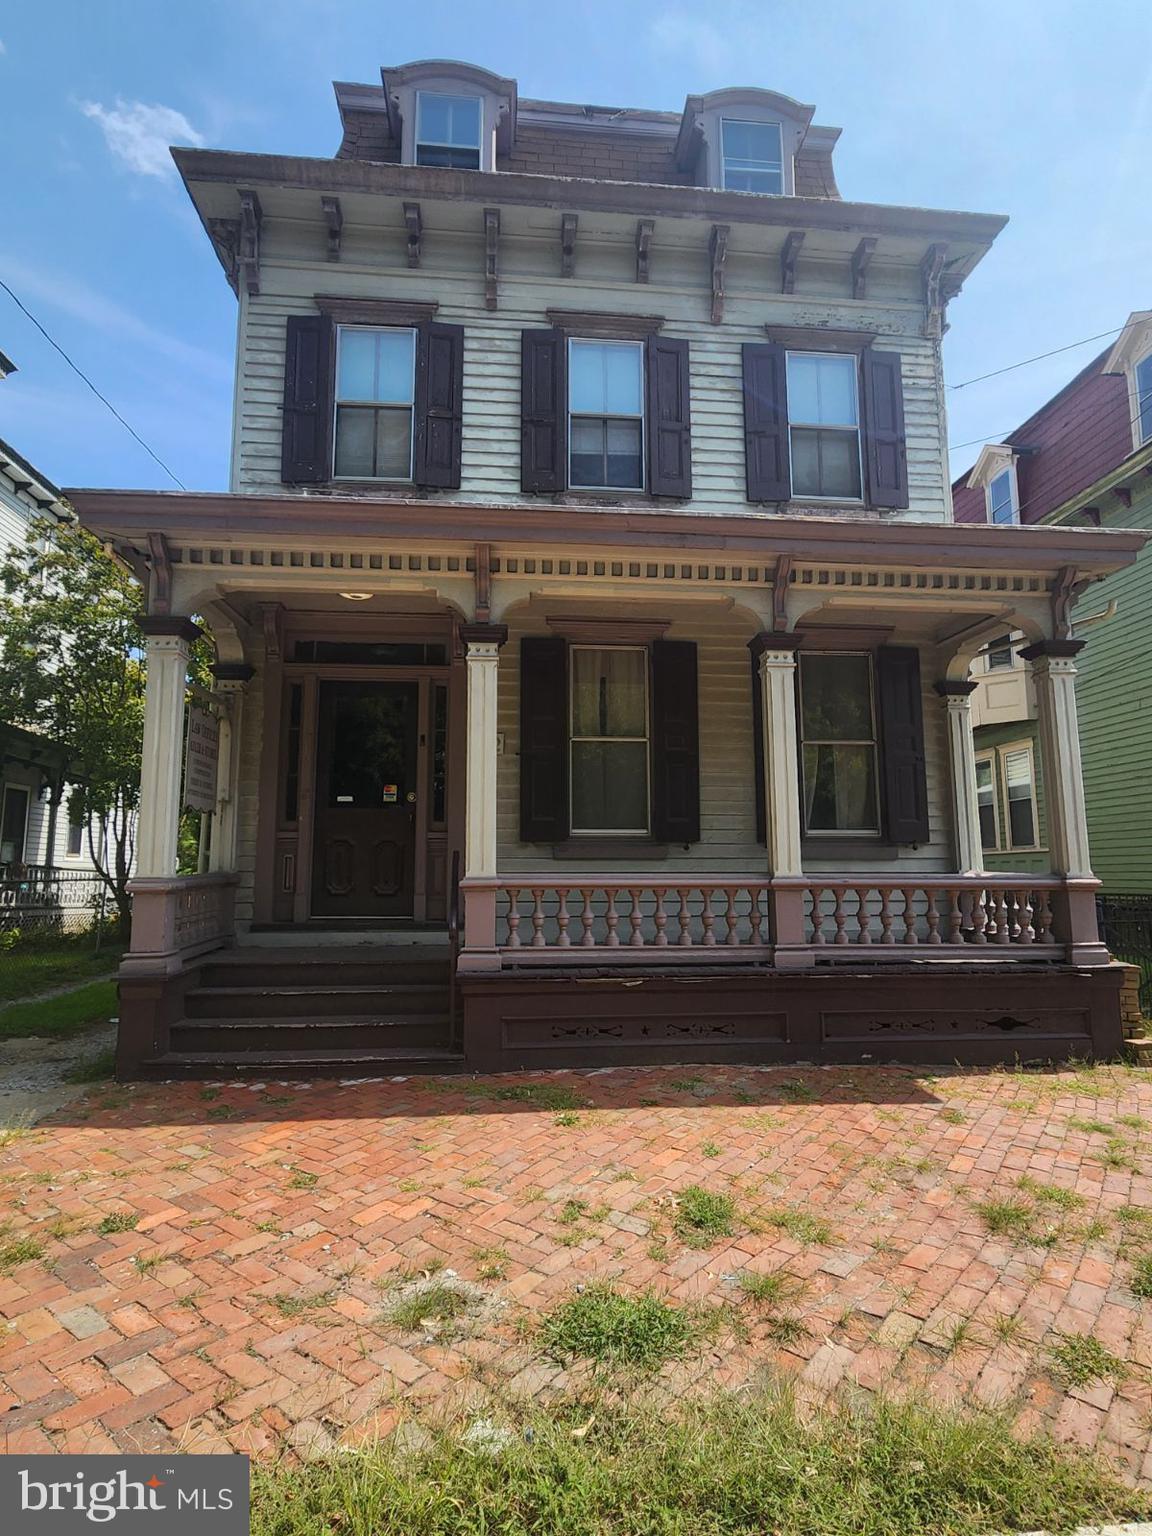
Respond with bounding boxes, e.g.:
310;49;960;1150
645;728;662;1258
539;1283;714;1370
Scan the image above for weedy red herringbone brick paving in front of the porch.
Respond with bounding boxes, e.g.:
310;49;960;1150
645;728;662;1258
0;1068;1152;1481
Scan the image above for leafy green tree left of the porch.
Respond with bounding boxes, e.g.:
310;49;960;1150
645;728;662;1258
0;519;144;932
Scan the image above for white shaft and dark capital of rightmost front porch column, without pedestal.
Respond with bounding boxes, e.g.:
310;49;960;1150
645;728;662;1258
1020;641;1092;879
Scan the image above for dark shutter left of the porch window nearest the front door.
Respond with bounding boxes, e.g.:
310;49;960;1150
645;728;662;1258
521;634;568;843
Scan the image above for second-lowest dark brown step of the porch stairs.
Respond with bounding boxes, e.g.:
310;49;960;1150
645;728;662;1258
169;1011;450;1052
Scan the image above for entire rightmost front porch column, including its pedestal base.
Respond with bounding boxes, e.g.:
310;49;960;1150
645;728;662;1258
1020;641;1109;965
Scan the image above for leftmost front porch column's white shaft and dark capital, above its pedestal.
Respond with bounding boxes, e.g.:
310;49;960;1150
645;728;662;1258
135;614;200;879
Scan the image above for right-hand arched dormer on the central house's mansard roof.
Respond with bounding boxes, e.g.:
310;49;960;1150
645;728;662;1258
676;86;816;197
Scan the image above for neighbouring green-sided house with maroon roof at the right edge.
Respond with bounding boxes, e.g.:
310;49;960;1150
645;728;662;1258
952;310;1152;1001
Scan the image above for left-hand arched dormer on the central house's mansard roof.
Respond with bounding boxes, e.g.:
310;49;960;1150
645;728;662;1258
379;58;516;170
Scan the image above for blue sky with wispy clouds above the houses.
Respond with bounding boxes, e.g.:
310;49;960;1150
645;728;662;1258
0;0;1152;490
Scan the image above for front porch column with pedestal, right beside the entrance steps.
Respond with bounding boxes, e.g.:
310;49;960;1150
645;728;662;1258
459;624;508;969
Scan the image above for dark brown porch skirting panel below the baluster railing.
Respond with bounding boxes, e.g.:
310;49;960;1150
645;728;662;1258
461;962;1123;1072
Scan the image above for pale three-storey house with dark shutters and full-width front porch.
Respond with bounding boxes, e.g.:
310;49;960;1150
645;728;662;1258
69;60;1144;1075
